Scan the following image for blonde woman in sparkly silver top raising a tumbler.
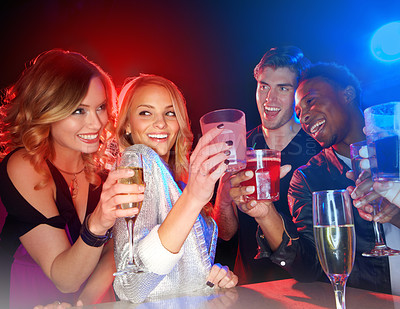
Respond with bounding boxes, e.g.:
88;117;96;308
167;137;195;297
114;75;237;302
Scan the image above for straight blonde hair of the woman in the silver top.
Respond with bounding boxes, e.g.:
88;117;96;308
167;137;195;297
116;74;193;183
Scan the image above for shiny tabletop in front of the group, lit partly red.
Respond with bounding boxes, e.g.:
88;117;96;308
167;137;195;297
73;279;400;309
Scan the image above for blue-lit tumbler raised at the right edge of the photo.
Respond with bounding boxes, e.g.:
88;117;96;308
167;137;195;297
364;102;400;181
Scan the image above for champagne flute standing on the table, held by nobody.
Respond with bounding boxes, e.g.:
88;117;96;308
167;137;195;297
313;190;356;309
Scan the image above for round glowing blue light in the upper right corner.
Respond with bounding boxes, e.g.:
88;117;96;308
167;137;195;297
371;21;400;62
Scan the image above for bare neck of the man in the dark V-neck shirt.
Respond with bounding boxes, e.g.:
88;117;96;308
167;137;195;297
262;118;301;151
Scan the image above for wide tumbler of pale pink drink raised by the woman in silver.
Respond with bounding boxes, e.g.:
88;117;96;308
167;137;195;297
200;109;246;172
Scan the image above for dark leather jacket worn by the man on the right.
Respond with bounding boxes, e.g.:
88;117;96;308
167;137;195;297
257;148;391;293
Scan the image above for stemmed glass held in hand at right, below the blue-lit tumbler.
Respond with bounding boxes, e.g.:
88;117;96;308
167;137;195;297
350;141;400;257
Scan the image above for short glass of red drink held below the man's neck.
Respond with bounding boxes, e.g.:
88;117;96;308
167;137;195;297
242;149;281;201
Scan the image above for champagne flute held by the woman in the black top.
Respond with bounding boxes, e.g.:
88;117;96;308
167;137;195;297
114;150;144;276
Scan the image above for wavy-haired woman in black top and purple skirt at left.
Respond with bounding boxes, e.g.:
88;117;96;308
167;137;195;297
0;50;144;308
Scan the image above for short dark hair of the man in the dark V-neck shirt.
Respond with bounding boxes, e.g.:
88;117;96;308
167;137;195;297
254;46;311;80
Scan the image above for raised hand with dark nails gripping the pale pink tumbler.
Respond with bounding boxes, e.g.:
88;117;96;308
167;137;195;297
185;128;232;205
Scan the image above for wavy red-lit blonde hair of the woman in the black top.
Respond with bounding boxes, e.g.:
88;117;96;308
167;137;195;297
0;49;116;189
